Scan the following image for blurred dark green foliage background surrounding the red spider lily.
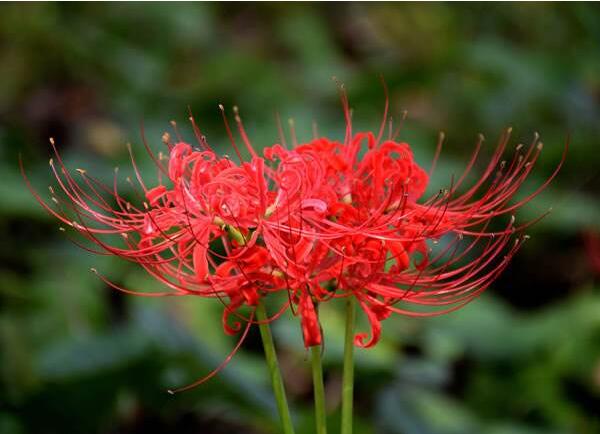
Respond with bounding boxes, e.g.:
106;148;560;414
0;3;600;434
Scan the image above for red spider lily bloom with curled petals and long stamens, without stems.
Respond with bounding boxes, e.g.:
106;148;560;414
23;89;566;386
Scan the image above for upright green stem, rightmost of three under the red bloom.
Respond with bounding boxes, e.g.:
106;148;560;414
342;295;356;434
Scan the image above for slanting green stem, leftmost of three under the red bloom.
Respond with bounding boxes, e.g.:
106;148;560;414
256;303;294;434
